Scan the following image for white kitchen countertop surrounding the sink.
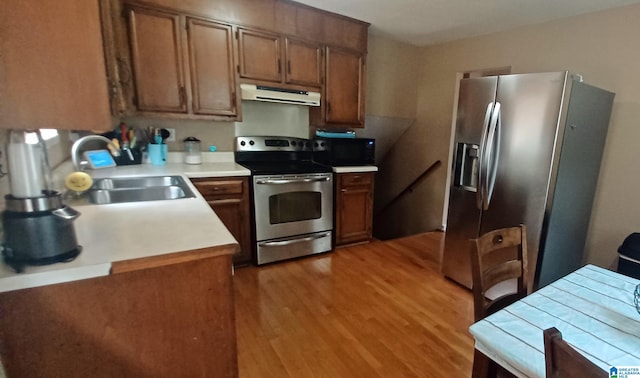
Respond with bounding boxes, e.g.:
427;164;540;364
0;152;250;292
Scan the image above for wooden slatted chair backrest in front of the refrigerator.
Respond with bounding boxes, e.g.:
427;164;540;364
471;225;529;321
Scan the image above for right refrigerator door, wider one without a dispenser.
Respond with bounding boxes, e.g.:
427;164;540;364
480;72;567;288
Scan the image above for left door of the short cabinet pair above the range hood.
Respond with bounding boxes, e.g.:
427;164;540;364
238;28;282;83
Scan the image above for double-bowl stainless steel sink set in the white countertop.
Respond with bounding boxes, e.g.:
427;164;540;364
88;176;195;205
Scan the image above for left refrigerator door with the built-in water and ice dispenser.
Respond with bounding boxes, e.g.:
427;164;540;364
442;77;498;288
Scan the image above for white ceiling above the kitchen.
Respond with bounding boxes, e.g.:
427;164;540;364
295;0;640;46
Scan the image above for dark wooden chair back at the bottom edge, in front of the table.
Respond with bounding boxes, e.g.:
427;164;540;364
543;327;609;378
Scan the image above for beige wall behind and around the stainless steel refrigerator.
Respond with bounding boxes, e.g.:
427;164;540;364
396;5;640;267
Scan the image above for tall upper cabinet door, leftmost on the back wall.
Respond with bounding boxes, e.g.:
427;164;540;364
128;8;187;113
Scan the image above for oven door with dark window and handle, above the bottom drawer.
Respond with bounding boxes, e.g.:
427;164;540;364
253;173;333;241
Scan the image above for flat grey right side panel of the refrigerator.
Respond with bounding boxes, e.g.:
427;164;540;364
534;82;614;287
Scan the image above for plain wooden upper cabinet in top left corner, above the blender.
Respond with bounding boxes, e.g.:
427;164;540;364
0;0;112;130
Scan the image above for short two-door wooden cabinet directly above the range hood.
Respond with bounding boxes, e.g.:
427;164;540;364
237;28;322;87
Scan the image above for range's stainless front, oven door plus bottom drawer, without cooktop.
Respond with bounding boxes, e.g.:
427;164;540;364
253;173;333;265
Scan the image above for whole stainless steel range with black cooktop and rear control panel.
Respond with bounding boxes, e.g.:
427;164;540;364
235;136;333;265
